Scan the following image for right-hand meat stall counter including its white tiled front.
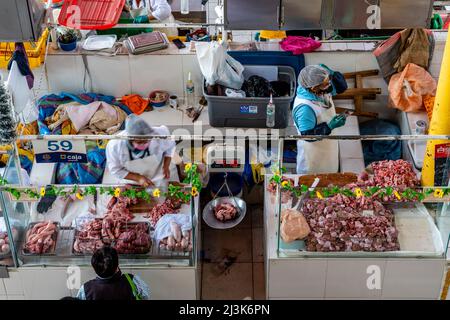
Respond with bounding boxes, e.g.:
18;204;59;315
264;145;450;299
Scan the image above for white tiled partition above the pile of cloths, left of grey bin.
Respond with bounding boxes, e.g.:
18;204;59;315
47;55;202;97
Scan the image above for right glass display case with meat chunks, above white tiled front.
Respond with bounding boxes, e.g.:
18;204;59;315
265;136;450;258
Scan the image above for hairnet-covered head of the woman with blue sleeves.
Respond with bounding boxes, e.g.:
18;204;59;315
298;65;333;95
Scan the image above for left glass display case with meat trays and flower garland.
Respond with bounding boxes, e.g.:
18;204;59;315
0;139;199;267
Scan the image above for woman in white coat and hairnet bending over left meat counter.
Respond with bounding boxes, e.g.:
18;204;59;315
103;114;178;187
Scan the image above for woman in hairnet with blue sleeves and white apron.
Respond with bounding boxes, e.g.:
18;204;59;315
292;65;345;174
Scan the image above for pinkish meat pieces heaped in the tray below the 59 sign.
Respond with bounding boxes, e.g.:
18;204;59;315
24;221;58;254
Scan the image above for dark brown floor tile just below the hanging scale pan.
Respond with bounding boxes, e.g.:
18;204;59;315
203;228;252;262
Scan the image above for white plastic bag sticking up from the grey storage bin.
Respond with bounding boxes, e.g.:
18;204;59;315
195;41;244;89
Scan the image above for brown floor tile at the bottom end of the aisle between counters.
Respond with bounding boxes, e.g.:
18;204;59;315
202;263;253;300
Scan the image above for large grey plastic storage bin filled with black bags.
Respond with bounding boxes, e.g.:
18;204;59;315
203;66;297;129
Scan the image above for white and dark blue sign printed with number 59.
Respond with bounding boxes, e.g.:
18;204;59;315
33;140;87;163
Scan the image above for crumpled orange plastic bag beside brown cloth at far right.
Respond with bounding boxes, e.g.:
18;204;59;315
389;63;436;112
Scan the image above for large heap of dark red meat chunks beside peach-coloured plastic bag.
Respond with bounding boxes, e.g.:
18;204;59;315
302;194;400;252
